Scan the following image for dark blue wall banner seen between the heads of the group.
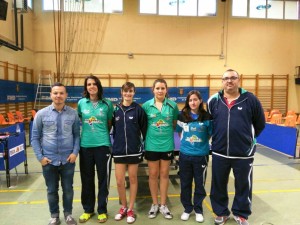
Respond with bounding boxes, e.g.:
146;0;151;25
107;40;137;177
67;86;209;104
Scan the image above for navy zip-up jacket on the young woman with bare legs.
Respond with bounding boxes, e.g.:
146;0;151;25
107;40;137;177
112;102;147;158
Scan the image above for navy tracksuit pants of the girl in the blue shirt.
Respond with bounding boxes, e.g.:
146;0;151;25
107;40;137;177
179;153;208;214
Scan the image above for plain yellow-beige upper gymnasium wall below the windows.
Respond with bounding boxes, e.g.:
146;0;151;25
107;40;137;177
0;0;300;112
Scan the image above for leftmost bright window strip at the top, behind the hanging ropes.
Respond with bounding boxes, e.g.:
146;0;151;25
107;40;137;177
43;0;123;13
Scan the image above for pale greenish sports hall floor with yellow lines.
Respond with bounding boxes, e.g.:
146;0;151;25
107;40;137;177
0;134;300;225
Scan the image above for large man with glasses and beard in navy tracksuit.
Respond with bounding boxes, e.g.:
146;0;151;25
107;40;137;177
207;69;265;225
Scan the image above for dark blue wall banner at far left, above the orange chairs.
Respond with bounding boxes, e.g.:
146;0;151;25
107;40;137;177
0;80;35;103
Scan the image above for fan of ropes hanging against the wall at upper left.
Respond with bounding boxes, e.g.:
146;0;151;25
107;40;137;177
53;0;109;85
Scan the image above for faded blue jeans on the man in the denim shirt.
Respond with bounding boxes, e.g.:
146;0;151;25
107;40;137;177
43;163;75;217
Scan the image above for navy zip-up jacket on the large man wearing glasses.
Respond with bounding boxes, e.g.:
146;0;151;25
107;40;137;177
207;88;265;158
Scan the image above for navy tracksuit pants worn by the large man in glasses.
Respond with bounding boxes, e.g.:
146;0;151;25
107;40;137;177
210;154;254;219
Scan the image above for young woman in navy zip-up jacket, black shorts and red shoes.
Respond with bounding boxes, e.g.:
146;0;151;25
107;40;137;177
112;82;147;223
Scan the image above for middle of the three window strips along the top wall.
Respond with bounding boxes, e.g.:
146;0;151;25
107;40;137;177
139;0;217;16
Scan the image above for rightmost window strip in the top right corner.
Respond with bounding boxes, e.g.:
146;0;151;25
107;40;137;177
232;0;300;20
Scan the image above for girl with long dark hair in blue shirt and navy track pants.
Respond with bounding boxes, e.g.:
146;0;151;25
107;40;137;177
176;90;212;222
